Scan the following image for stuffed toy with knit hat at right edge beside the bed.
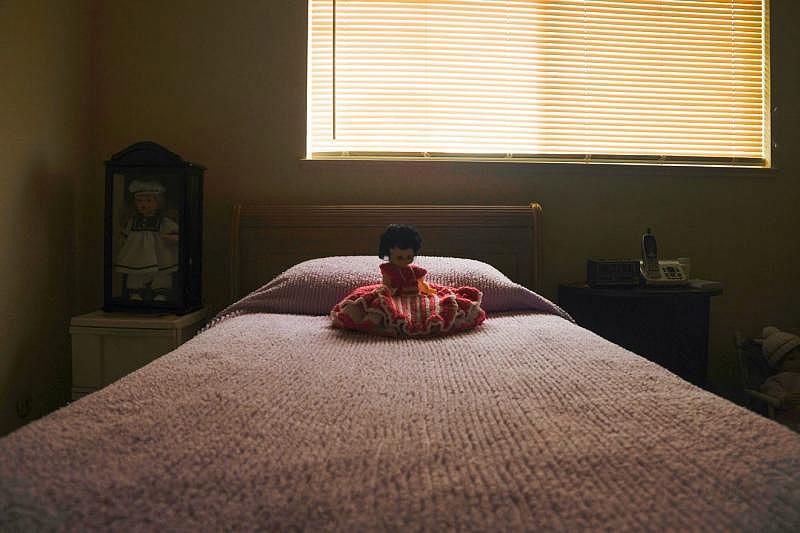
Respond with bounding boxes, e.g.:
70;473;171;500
759;326;800;410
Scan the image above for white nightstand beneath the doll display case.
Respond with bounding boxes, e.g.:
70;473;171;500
69;308;208;400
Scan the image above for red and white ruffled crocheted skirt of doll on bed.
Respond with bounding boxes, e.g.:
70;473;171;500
330;284;486;336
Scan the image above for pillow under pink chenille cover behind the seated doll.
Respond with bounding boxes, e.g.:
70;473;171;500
214;255;571;323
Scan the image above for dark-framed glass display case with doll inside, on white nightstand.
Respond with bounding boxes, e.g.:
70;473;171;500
103;142;205;315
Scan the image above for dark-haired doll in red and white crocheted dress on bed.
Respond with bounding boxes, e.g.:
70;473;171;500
330;224;486;336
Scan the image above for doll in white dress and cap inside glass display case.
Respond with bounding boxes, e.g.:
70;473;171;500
114;180;179;302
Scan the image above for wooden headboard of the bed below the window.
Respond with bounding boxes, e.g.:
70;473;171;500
231;203;542;299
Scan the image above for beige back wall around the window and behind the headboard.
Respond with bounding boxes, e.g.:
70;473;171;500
79;0;800;400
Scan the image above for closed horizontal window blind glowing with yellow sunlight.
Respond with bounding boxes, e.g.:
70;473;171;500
307;0;770;166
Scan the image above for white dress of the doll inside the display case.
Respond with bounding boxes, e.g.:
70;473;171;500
114;217;178;274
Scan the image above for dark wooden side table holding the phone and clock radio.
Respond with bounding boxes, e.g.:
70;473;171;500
558;283;722;387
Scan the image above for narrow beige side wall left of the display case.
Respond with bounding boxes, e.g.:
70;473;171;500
0;0;89;435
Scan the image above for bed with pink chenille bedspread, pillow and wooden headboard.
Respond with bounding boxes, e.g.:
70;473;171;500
0;204;800;531
